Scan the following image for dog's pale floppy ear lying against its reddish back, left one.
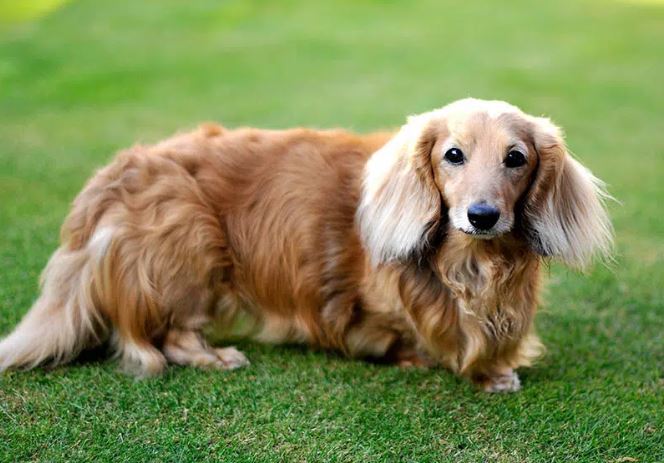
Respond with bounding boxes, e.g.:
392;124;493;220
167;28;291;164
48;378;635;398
357;115;442;265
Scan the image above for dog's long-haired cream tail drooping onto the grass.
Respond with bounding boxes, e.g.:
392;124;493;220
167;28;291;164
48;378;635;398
0;237;110;371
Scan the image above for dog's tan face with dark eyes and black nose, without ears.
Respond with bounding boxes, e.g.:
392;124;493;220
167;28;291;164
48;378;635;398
428;100;538;239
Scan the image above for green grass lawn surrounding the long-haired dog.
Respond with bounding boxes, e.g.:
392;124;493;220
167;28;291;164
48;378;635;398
0;0;664;462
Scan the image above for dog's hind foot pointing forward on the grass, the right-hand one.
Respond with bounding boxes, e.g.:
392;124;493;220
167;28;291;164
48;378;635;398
162;329;249;370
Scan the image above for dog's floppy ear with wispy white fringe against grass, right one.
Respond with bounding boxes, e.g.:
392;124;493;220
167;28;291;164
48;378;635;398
523;118;613;268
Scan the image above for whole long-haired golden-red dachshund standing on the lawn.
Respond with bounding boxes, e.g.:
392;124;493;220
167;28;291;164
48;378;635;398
0;99;613;392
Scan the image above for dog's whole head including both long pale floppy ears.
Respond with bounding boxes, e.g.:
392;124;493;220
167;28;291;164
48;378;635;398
358;99;612;267
